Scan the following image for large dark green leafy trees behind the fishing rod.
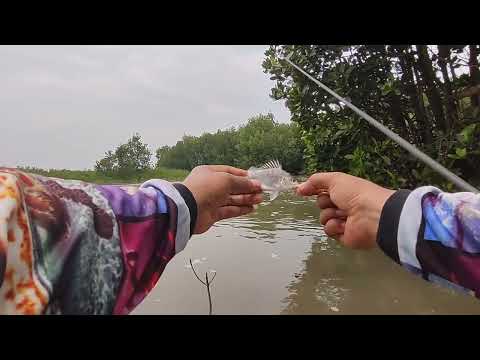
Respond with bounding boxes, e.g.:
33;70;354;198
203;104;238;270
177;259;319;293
263;45;480;189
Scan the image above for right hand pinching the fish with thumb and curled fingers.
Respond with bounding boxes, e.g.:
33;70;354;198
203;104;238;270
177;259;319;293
297;172;395;249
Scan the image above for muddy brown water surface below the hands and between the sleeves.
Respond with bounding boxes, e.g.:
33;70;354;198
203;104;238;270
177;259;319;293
133;194;480;315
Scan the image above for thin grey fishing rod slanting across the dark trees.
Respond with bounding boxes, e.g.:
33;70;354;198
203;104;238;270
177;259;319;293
284;53;479;193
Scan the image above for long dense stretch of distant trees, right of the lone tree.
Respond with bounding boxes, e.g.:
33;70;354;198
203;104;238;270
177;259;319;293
156;114;304;173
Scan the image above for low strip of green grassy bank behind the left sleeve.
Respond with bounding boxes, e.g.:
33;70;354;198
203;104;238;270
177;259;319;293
21;167;188;184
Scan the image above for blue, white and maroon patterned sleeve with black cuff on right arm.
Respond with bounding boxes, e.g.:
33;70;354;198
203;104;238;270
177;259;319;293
377;186;480;298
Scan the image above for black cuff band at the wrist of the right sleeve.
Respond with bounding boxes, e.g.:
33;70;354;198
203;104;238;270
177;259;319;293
377;190;411;264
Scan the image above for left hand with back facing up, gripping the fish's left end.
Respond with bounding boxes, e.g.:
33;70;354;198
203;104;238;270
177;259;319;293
183;165;263;234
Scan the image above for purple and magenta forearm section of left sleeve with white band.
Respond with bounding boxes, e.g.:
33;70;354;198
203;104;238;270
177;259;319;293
98;180;190;314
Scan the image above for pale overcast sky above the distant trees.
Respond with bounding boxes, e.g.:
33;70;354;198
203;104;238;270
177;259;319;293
0;46;289;169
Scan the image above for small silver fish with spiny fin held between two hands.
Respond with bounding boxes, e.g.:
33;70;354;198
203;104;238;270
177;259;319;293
248;160;299;201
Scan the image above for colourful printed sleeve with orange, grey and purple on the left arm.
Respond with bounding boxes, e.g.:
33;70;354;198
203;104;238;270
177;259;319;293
0;168;197;314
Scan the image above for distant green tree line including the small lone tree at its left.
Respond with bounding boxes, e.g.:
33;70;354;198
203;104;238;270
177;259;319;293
91;114;304;179
